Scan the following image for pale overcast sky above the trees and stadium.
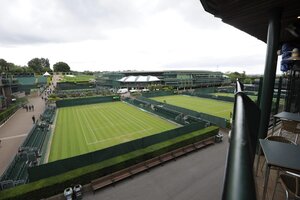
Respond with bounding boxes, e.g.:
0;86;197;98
0;0;278;74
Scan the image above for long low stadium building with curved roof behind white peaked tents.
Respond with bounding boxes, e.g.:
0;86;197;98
96;70;230;89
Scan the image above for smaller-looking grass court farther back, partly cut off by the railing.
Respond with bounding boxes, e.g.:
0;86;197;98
152;95;233;119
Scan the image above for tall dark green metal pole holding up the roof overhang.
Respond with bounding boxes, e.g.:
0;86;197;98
258;8;281;138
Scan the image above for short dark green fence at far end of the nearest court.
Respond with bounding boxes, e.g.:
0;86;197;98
56;96;120;108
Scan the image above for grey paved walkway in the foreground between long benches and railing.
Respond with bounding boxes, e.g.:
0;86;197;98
76;133;228;200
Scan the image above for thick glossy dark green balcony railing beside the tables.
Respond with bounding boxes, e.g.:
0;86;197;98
222;81;260;200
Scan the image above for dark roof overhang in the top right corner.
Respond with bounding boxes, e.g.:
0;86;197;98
200;0;300;44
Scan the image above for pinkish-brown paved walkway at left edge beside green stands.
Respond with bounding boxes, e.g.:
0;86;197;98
0;96;45;175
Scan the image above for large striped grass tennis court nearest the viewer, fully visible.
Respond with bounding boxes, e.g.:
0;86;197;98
48;102;177;162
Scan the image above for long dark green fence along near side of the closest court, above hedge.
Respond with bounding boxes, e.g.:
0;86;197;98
28;123;209;182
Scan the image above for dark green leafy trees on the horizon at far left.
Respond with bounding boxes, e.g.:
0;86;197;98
0;58;71;74
